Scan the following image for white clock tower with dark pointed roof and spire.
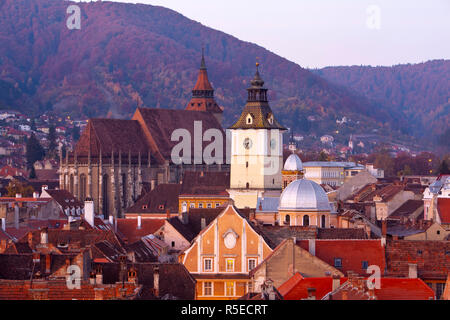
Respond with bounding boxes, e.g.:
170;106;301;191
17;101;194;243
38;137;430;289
228;64;286;208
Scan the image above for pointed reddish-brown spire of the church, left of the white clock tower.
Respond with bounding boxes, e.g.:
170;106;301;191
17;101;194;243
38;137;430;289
186;50;223;124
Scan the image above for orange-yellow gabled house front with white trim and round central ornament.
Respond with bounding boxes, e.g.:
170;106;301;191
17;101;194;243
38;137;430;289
180;205;272;300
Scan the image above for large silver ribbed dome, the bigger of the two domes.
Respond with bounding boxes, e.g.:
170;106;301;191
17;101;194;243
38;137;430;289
279;179;331;211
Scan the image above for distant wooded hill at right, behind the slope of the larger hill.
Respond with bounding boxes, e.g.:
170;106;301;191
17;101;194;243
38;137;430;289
313;60;450;146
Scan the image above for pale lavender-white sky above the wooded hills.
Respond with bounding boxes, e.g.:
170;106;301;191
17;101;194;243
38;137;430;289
77;0;450;68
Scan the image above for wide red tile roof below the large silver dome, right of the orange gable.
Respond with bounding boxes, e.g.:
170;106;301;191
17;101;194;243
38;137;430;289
297;240;386;275
